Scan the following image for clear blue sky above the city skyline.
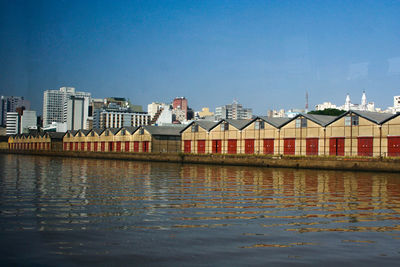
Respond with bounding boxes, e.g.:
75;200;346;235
0;0;400;115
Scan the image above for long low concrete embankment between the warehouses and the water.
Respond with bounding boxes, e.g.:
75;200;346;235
0;150;400;172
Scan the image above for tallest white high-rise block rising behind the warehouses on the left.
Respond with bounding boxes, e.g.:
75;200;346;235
43;87;91;130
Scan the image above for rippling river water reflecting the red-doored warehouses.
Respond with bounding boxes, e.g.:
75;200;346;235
0;154;400;266
